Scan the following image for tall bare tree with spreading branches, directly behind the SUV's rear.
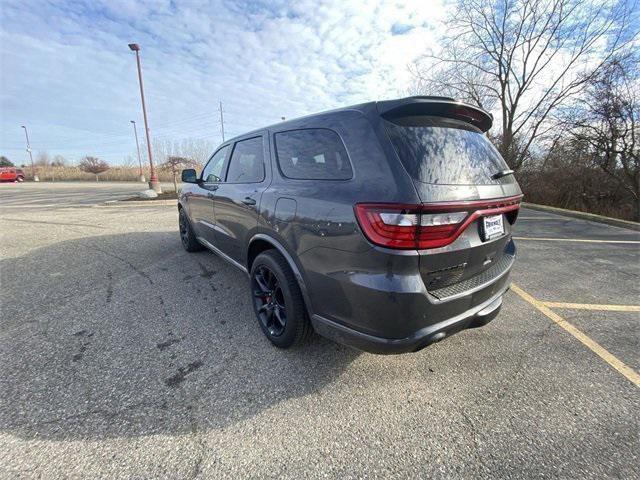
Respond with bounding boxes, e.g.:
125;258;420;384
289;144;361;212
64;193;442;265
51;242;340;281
411;0;635;169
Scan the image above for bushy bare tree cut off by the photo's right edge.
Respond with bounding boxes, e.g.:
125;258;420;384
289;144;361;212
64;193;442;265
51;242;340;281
570;54;640;221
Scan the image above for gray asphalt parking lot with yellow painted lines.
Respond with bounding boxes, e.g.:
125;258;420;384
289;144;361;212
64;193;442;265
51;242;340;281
0;184;640;479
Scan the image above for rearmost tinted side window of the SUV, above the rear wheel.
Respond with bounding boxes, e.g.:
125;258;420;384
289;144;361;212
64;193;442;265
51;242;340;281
275;128;353;180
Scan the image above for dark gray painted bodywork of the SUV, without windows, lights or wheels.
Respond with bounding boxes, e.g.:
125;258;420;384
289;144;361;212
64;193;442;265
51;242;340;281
179;97;520;351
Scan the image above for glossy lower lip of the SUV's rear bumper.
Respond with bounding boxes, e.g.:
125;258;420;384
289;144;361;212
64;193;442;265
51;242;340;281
311;284;509;354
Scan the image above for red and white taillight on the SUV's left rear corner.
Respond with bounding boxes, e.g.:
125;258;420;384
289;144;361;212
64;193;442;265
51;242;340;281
355;195;522;250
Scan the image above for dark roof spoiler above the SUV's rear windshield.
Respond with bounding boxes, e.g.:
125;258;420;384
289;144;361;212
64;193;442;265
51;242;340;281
377;96;493;132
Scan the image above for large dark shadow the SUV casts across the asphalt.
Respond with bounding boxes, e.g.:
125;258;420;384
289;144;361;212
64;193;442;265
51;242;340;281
0;231;359;440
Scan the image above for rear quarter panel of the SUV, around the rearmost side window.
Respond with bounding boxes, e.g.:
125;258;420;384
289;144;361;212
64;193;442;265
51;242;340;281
259;110;419;319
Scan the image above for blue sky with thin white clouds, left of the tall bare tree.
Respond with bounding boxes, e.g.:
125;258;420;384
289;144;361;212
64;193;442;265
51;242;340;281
0;0;444;164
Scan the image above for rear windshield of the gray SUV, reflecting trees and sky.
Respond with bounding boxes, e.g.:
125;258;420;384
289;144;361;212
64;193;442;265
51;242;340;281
385;116;515;185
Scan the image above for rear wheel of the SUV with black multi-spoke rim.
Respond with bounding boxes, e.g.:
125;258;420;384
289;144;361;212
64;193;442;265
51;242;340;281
250;250;313;348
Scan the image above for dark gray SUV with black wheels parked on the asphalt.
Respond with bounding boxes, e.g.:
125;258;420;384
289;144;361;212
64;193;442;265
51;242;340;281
178;97;522;353
